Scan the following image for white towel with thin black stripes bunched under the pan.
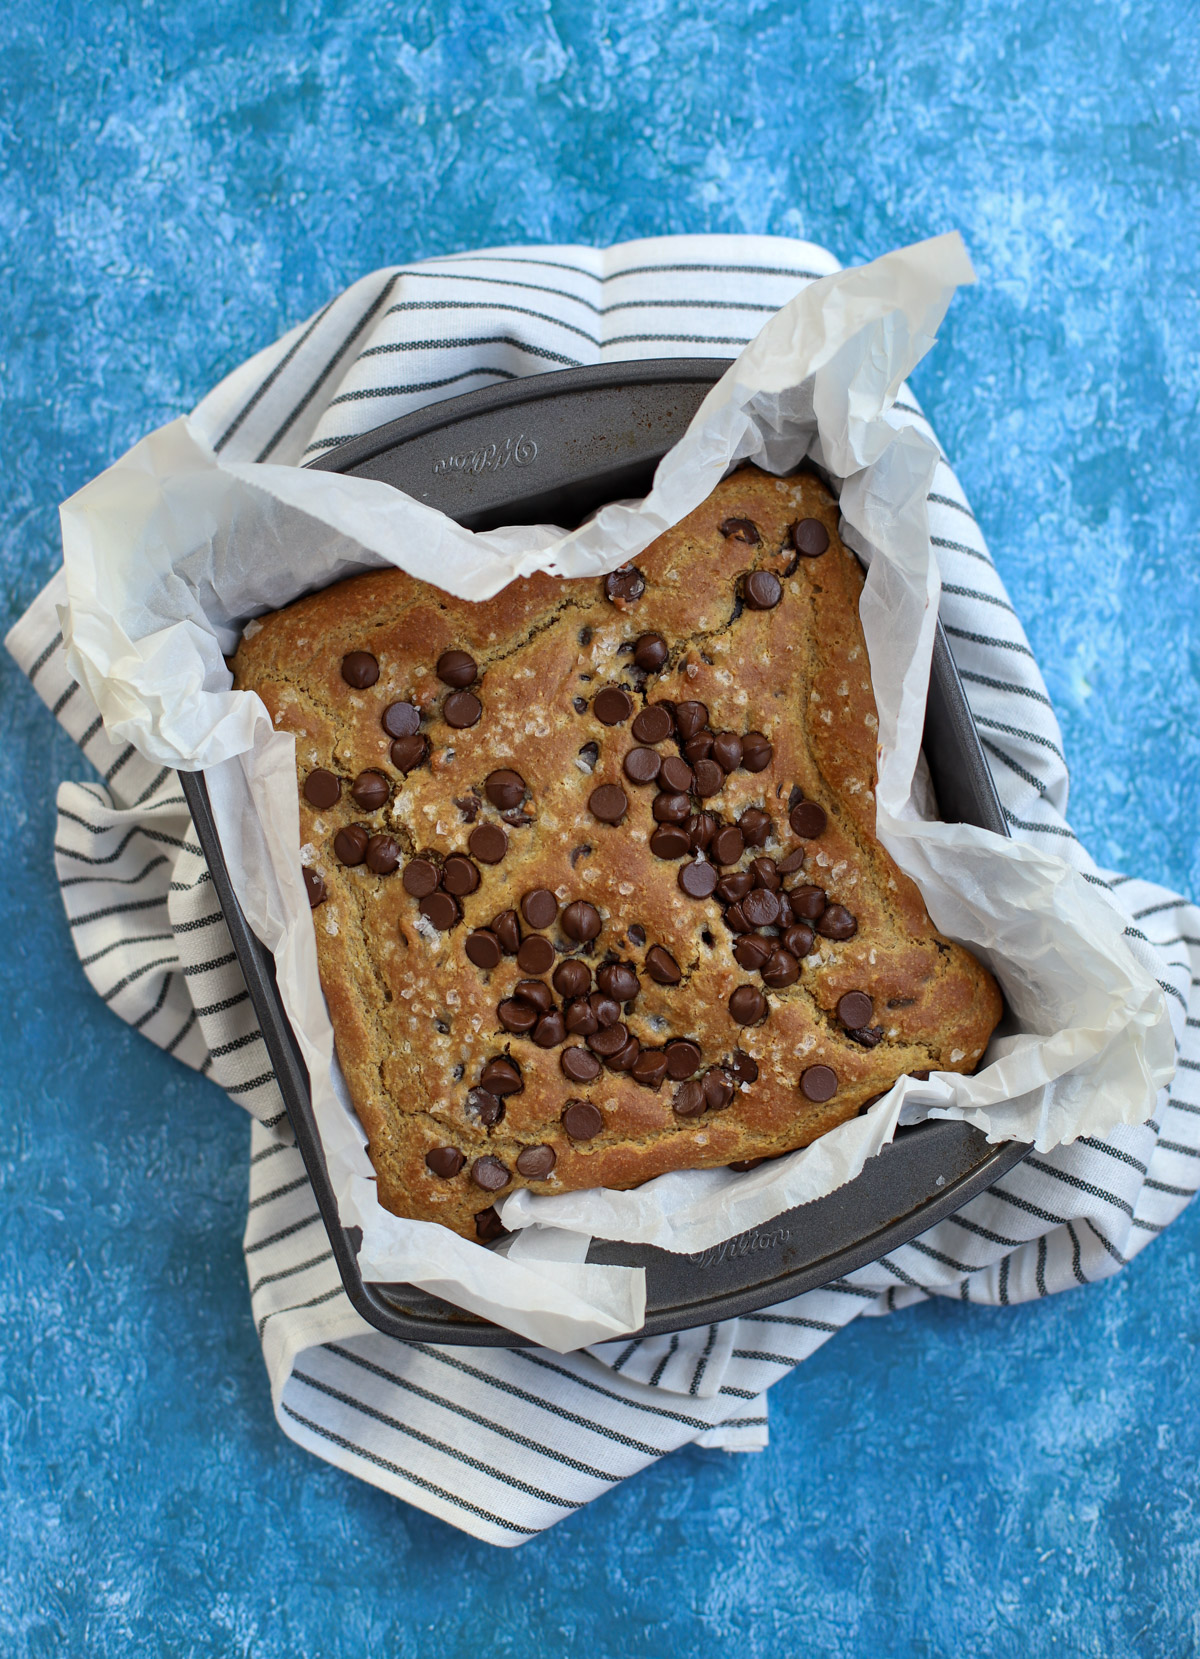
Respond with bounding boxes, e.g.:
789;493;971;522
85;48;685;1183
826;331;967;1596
8;237;1200;1545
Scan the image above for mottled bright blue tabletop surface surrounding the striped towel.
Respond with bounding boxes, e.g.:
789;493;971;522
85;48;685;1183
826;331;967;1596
0;0;1200;1659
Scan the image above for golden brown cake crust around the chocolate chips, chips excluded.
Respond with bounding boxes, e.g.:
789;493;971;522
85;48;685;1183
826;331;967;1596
234;468;1001;1238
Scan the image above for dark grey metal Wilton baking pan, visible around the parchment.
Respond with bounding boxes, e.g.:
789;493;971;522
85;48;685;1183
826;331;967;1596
181;358;1029;1347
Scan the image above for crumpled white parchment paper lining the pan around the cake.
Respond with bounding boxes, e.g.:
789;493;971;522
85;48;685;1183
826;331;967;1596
61;234;1173;1350
